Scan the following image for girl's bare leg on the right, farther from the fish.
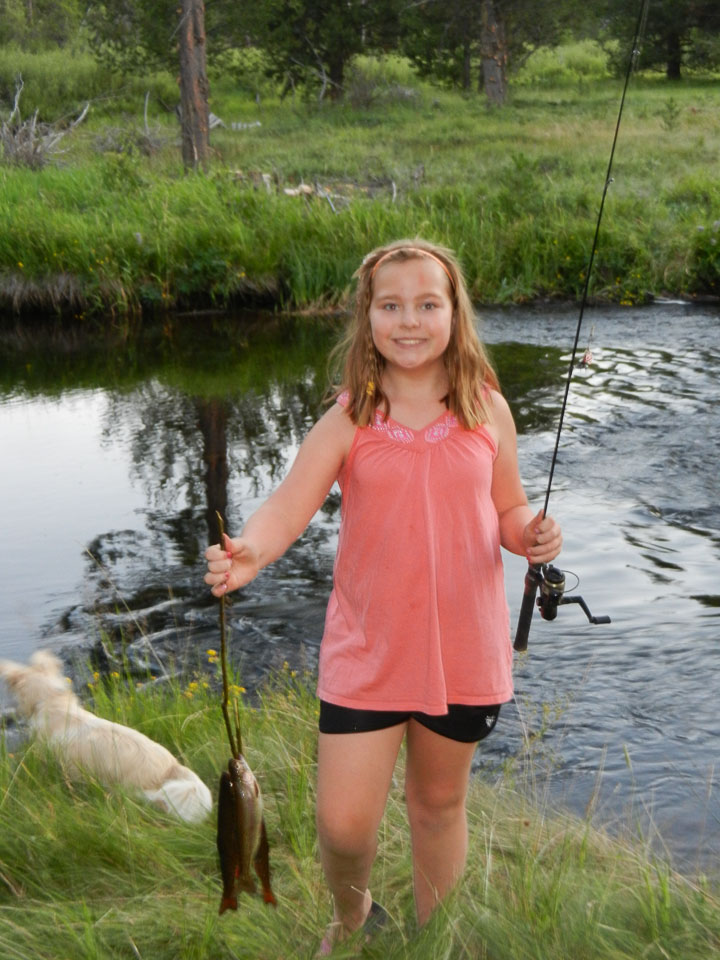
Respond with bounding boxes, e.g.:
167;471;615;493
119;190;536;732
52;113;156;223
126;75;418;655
405;720;477;926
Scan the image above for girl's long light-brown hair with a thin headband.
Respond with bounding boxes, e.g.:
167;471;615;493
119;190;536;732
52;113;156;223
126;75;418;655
331;239;499;430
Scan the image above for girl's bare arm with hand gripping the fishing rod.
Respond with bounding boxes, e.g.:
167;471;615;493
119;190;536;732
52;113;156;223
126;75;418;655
492;391;562;563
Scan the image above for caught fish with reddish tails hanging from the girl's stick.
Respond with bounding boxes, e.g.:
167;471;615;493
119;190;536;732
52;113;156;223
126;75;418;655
217;754;277;914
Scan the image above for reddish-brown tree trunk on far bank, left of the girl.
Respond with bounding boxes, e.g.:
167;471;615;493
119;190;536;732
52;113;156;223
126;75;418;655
179;0;210;170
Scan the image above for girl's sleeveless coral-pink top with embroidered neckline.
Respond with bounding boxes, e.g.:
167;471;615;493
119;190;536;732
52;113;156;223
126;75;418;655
318;394;513;714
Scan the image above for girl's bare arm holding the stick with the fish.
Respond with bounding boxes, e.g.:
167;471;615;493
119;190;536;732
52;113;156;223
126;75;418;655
205;404;355;597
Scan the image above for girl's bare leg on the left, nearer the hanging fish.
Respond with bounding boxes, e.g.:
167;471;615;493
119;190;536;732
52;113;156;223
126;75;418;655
317;724;406;940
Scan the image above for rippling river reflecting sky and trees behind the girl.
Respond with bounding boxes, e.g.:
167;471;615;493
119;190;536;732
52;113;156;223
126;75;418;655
0;303;720;872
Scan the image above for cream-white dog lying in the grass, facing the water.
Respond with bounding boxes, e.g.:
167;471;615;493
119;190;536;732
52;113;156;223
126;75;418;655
0;650;212;822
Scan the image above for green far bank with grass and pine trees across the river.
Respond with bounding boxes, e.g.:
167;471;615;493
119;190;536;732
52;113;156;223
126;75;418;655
0;0;720;316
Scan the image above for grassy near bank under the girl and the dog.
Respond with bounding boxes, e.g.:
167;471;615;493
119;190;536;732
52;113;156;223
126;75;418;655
0;666;720;960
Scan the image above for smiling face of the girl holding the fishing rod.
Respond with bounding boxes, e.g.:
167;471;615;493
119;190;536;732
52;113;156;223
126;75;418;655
369;257;453;371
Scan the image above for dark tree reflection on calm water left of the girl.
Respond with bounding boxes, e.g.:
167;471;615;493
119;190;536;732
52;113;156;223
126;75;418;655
54;318;337;676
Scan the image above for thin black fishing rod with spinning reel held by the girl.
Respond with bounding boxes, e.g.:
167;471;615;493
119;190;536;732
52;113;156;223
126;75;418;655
513;0;649;652
